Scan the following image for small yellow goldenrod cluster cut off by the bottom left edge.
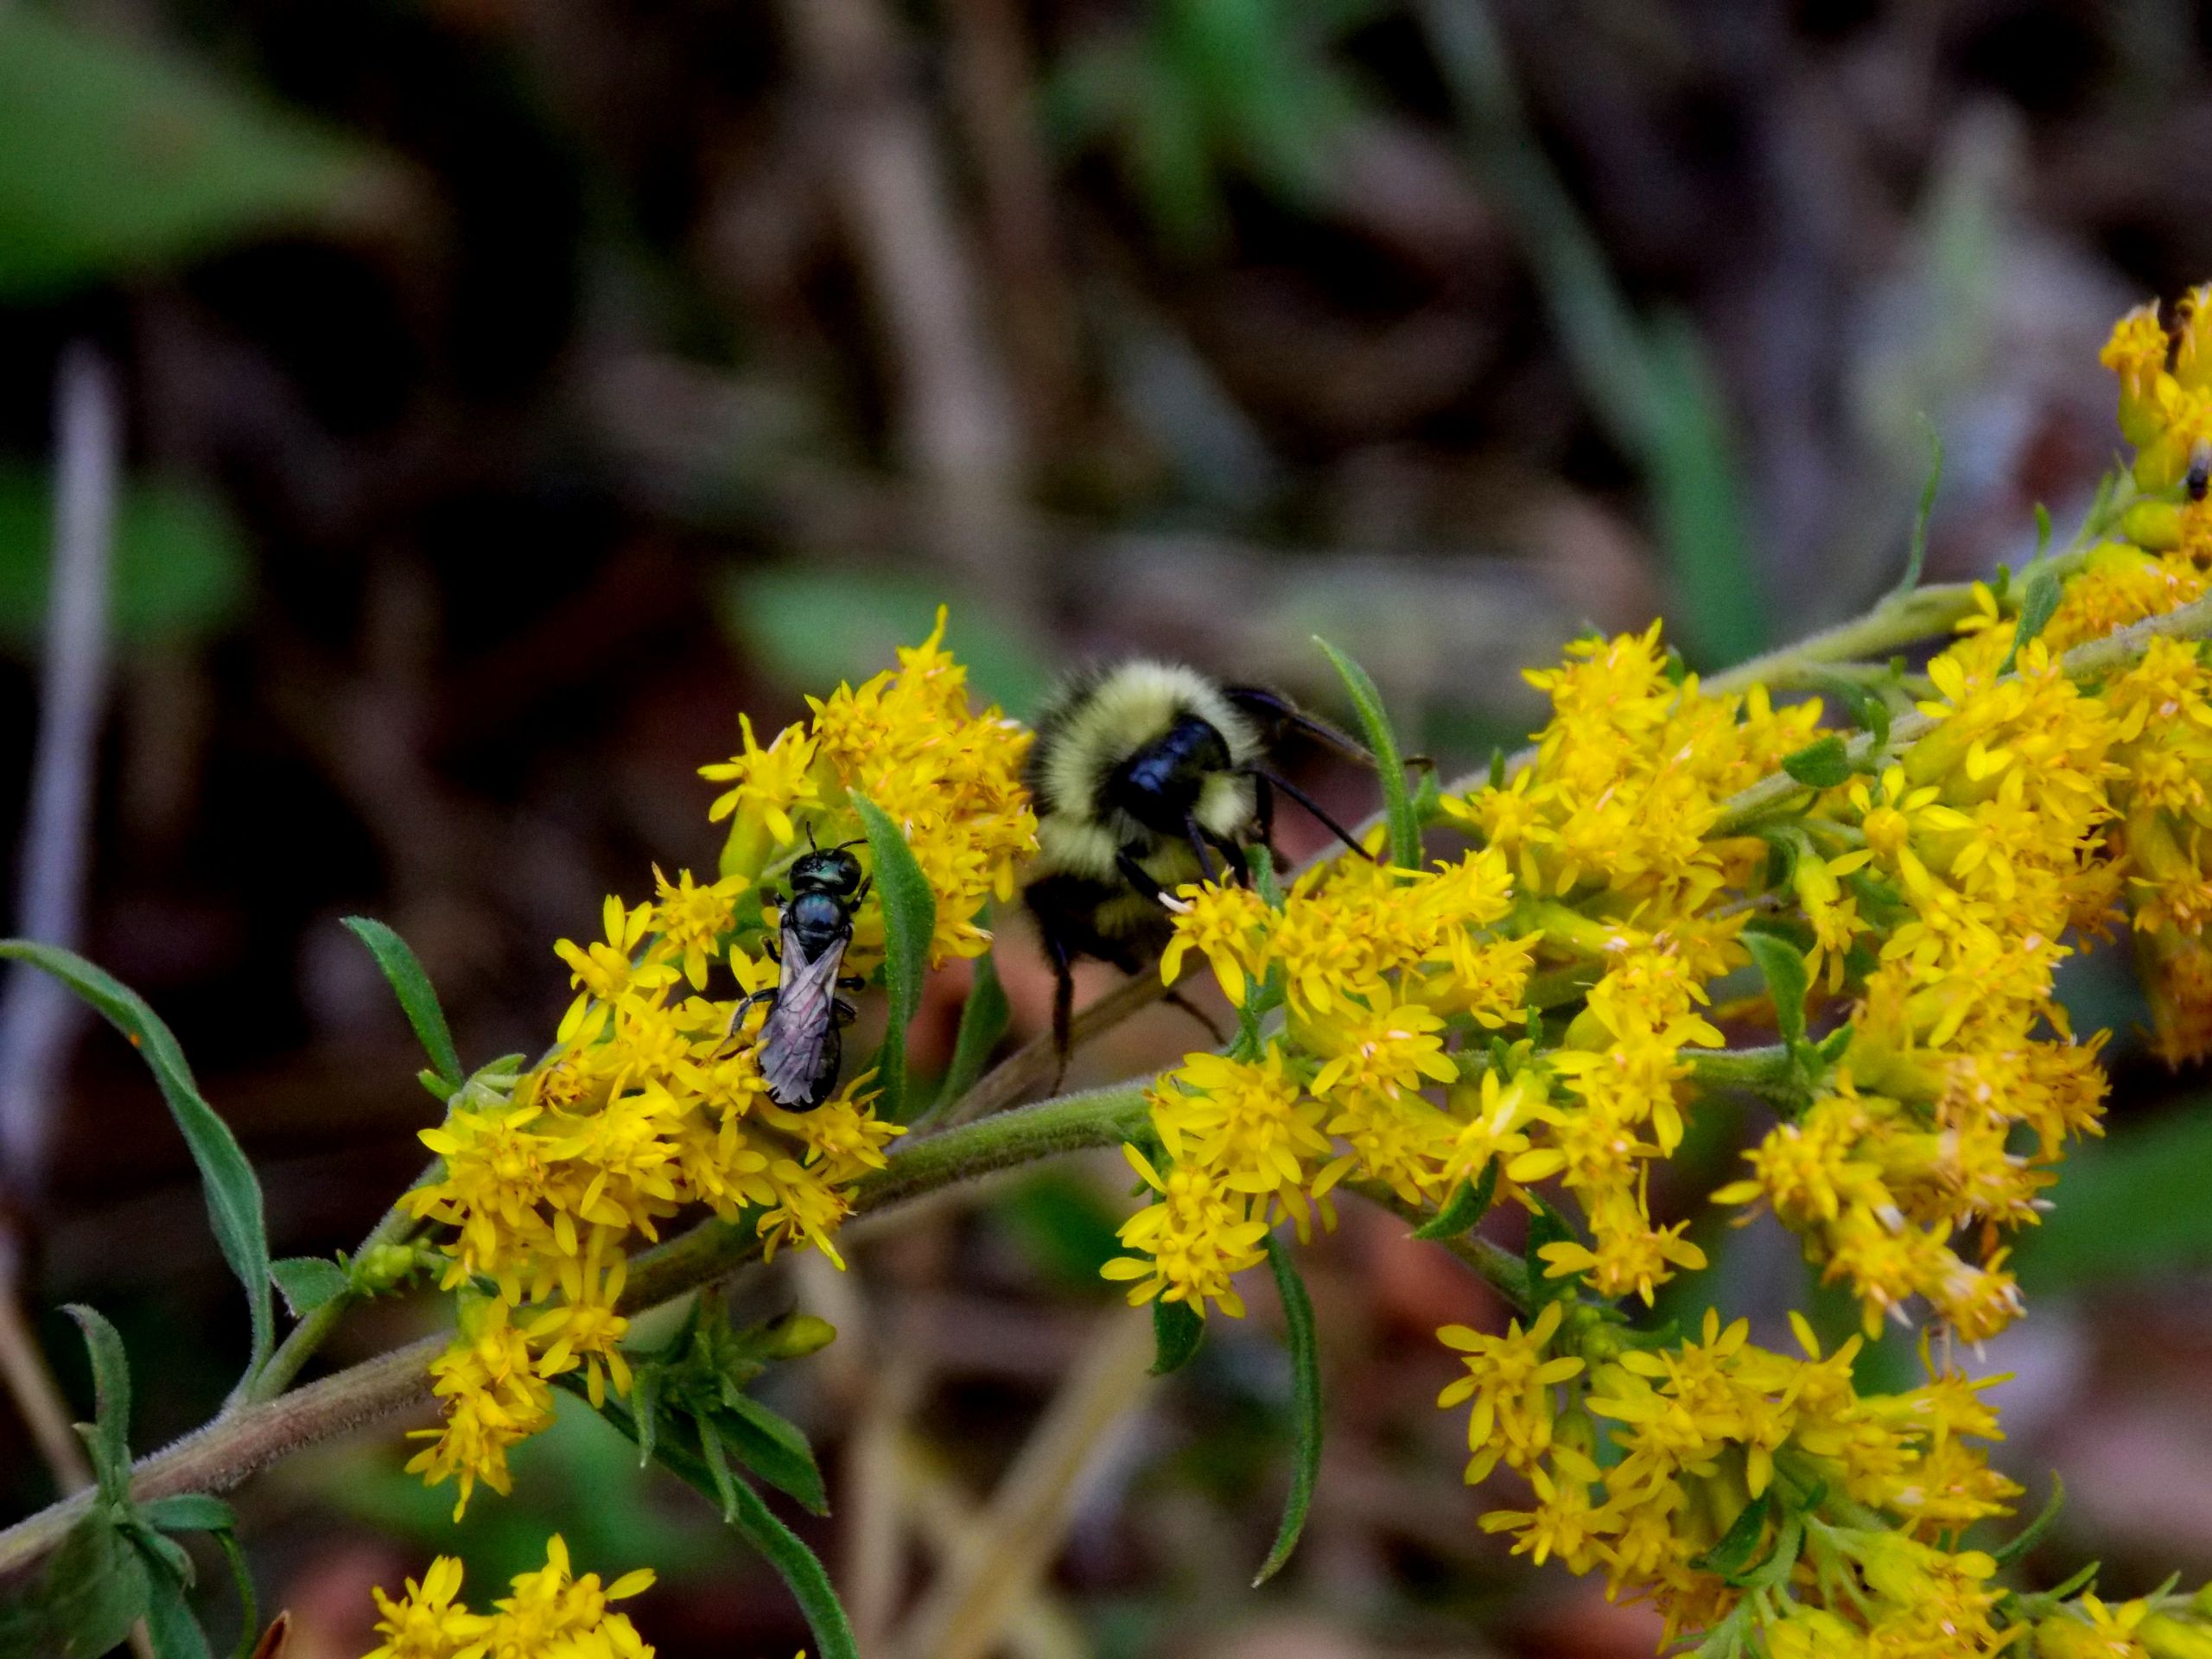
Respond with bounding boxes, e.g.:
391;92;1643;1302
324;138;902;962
367;1533;652;1659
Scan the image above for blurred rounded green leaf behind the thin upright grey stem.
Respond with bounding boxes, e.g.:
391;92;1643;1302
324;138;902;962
0;471;252;652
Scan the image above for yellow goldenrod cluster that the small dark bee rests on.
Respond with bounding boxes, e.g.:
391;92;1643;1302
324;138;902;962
407;611;1035;1513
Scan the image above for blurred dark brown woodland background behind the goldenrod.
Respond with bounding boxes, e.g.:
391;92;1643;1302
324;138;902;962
0;0;2212;1659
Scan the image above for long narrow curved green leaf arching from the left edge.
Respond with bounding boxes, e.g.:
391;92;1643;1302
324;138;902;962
0;946;276;1376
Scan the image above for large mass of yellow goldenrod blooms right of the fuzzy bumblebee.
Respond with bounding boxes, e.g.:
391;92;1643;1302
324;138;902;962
1106;289;2212;1659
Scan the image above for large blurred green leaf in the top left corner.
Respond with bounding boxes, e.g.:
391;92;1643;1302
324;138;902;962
0;7;400;303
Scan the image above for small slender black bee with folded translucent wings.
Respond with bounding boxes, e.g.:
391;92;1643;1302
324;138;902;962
730;830;872;1113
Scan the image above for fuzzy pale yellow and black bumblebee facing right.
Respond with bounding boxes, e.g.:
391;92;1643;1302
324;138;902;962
1024;661;1374;1062
